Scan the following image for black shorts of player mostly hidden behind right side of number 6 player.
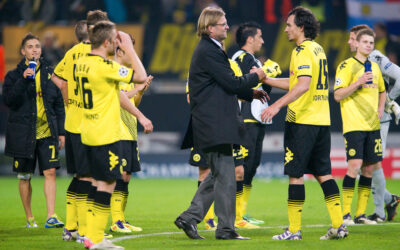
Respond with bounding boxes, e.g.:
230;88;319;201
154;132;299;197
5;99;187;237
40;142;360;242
120;141;140;174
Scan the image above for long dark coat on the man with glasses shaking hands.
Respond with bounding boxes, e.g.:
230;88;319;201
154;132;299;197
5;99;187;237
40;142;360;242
182;36;258;149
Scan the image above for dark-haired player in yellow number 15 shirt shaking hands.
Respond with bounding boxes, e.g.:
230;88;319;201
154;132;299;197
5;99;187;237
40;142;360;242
261;7;348;240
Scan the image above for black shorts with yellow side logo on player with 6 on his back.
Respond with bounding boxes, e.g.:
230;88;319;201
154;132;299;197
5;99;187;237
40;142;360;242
85;141;123;181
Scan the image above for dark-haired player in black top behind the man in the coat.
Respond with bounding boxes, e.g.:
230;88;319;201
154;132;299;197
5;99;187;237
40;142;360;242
232;22;279;225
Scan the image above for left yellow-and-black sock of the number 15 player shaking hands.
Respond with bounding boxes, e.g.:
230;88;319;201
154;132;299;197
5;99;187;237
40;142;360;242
288;184;305;233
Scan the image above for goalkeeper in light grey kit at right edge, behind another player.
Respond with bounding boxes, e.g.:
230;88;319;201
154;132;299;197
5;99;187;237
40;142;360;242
348;24;400;222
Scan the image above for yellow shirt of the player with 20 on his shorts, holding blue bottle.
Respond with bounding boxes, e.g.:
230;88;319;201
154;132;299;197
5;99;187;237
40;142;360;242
335;57;385;134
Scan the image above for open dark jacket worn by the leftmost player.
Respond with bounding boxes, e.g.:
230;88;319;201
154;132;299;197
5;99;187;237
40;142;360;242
3;59;65;158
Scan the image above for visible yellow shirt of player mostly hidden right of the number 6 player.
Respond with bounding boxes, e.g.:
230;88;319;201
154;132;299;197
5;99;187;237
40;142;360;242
119;82;137;141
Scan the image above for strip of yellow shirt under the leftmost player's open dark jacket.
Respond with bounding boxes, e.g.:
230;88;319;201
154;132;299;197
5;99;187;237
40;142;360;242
35;64;51;140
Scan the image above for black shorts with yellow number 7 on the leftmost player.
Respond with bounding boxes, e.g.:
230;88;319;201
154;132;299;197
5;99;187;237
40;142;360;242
13;137;60;175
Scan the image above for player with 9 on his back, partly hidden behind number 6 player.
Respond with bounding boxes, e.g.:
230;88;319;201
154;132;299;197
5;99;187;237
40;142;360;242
52;10;108;243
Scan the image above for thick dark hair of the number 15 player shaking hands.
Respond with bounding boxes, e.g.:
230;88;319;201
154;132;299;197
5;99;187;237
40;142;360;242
288;6;320;39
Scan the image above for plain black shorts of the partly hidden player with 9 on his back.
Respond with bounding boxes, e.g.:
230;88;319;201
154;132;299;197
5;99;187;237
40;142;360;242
65;131;90;177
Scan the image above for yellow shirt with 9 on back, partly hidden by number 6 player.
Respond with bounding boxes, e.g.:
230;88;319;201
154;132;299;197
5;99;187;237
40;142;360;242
55;42;91;134
